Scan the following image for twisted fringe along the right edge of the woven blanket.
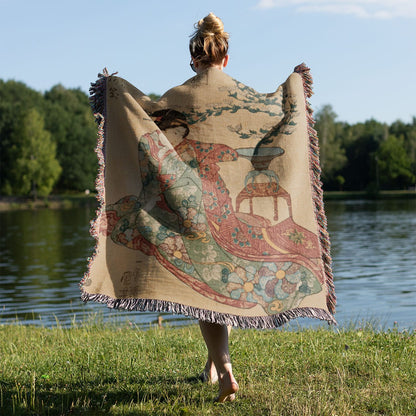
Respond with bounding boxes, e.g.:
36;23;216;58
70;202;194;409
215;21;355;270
294;63;336;313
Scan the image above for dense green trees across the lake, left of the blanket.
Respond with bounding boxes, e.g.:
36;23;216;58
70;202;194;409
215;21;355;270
0;80;97;197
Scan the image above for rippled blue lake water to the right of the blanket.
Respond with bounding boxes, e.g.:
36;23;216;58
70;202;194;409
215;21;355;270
326;200;416;327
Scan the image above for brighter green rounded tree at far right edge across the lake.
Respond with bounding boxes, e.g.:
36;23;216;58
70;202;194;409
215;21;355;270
376;135;415;189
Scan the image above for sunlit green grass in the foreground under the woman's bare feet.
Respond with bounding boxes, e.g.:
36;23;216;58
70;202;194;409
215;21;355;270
0;324;416;416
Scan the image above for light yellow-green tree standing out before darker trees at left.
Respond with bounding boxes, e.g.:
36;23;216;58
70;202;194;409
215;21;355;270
11;109;61;198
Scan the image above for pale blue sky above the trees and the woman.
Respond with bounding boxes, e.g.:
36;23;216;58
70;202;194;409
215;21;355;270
0;0;416;124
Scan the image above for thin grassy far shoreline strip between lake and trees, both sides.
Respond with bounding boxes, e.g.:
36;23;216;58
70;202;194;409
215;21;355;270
0;191;416;212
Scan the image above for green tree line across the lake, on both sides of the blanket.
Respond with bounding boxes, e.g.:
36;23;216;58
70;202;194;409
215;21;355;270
0;80;416;197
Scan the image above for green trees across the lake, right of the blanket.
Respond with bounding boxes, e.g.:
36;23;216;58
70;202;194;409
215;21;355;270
315;105;416;192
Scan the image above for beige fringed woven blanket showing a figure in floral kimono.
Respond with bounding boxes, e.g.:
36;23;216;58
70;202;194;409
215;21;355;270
81;64;335;328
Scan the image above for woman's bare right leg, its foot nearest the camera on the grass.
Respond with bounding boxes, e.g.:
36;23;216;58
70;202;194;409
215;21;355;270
199;321;238;402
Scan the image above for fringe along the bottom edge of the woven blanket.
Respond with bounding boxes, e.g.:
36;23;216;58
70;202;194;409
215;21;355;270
81;291;336;329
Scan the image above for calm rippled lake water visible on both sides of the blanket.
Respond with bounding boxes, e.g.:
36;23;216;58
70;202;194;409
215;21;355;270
0;200;416;329
